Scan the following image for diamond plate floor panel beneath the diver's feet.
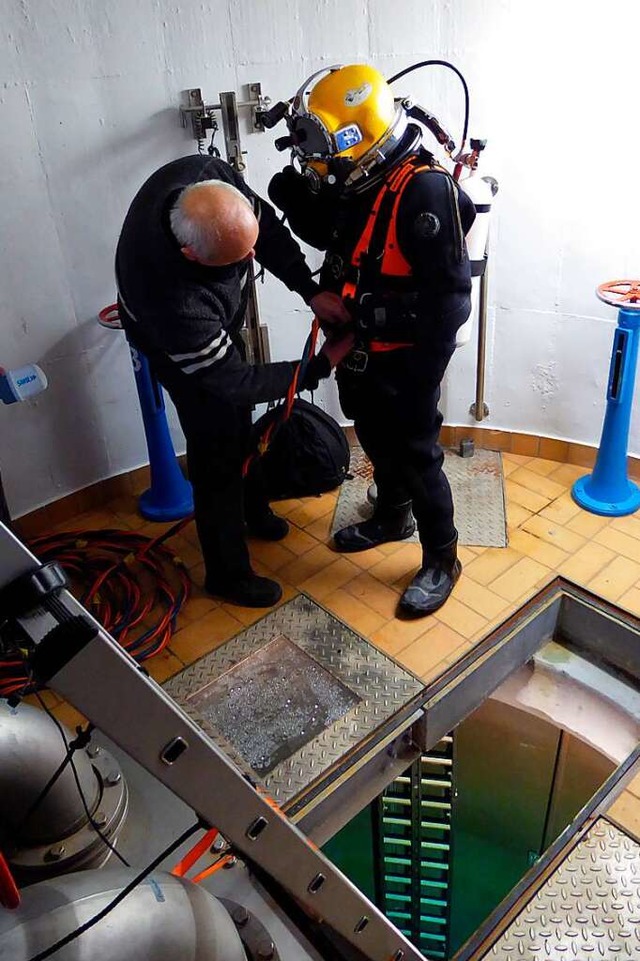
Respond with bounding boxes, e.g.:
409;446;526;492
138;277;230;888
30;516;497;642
331;446;507;547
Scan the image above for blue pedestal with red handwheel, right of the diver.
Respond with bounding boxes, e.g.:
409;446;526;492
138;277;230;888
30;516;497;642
572;281;640;517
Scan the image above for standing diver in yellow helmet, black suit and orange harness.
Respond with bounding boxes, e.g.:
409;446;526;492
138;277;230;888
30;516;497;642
269;65;475;617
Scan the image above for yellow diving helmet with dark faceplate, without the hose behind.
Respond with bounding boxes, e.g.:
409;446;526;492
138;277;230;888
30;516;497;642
283;64;407;186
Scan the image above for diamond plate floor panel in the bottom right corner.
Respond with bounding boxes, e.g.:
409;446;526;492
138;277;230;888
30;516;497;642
485;819;640;961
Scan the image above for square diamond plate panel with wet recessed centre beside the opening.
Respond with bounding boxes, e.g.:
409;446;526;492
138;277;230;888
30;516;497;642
164;594;423;804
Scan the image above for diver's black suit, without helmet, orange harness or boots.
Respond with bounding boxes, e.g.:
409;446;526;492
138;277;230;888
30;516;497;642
269;139;475;551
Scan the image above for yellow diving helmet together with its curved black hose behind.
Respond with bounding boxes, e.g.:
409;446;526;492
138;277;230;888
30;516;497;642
261;60;484;191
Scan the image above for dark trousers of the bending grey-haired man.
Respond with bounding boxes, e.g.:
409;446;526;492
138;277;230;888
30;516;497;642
151;362;269;582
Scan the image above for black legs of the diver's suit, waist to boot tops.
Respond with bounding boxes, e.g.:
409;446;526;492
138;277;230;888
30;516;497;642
338;309;468;551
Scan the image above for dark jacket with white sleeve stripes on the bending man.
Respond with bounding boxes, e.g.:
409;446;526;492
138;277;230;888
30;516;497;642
116;155;319;405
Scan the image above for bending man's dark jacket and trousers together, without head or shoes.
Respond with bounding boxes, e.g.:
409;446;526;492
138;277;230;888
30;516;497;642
116;155;319;581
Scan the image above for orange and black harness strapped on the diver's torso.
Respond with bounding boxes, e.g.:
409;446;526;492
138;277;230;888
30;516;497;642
325;154;464;373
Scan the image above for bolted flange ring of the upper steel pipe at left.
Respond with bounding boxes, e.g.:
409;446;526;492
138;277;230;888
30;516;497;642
8;744;129;884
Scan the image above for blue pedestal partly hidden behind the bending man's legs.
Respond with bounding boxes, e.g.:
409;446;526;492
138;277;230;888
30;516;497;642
129;345;193;521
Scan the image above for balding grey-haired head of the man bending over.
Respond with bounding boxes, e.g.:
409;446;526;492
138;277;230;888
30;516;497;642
170;180;258;267
